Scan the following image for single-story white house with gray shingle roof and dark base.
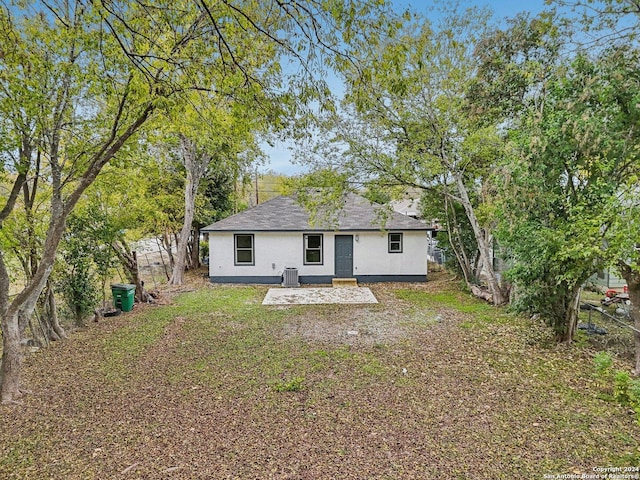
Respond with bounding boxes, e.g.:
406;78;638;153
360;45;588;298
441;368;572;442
202;194;432;284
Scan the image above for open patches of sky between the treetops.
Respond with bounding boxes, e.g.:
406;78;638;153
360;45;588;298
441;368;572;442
259;0;545;175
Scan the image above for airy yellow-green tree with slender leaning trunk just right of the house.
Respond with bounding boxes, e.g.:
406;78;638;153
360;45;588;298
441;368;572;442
302;9;506;304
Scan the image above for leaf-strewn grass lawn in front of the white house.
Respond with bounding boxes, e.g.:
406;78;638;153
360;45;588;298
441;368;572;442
0;277;640;480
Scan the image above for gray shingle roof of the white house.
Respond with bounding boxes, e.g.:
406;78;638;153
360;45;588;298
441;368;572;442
202;194;432;232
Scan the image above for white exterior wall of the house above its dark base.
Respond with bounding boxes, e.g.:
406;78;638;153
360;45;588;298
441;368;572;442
209;231;427;277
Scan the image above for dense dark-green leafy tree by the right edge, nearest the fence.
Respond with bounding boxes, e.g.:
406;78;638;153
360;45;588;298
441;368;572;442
470;5;640;351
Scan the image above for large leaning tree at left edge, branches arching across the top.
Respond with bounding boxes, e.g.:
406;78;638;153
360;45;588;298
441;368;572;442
0;0;396;402
